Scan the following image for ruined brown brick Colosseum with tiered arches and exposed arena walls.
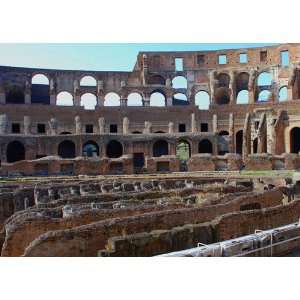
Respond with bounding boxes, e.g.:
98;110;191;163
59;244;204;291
0;44;300;256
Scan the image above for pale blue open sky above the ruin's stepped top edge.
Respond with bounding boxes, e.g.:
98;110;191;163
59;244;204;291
0;43;272;71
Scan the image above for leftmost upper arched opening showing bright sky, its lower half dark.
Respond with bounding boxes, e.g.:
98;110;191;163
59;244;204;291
31;74;50;104
